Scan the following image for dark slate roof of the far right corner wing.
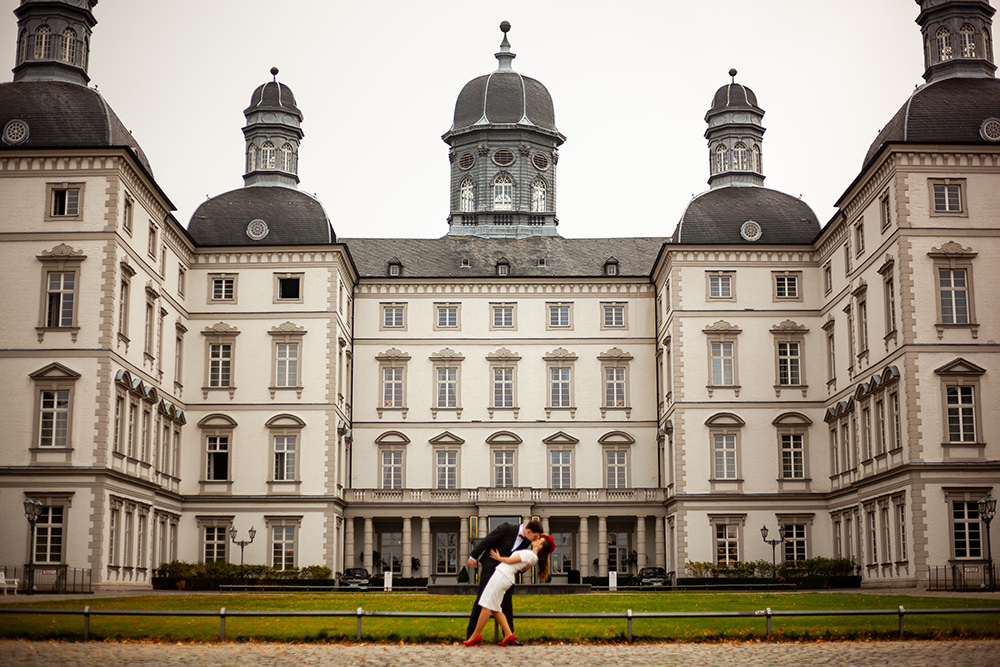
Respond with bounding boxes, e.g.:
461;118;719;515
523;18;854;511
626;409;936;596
864;77;1000;167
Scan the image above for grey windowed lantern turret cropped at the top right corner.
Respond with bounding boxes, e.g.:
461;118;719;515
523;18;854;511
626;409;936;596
916;0;997;83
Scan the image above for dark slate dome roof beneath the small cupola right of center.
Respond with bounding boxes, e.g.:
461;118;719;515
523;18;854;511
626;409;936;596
673;186;819;245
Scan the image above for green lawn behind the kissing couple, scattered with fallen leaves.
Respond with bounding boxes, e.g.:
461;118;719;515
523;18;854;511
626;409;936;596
0;592;1000;643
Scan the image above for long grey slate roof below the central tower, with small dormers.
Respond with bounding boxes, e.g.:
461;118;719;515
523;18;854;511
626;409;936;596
340;236;667;279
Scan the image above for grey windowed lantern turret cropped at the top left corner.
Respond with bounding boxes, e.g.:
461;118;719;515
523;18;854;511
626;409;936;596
13;0;97;86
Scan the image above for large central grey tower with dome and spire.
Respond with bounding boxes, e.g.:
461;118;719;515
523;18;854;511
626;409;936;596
442;21;566;238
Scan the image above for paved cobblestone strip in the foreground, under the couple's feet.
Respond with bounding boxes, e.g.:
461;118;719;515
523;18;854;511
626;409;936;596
0;640;1000;667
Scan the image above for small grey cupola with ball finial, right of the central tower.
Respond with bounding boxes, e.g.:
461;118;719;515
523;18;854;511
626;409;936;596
705;69;764;188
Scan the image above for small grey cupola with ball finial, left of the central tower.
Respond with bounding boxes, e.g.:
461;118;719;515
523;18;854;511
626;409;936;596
243;67;303;188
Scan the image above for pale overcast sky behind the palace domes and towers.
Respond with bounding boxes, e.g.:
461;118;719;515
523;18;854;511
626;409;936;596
0;0;948;238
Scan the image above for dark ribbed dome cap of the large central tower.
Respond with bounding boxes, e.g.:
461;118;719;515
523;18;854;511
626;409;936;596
451;72;559;132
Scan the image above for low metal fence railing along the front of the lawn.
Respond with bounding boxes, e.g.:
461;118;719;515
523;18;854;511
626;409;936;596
0;605;1000;641
